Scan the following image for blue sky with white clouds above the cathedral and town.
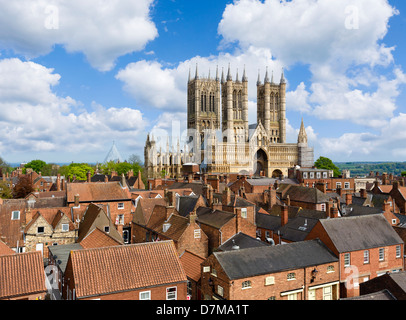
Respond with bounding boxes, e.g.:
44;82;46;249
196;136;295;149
0;0;406;163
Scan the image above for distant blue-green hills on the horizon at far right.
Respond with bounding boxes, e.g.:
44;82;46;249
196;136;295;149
334;162;406;177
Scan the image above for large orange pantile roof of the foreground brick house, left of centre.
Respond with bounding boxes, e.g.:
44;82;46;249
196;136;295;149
71;241;187;298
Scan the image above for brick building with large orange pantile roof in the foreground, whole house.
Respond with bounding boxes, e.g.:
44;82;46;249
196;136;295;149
62;241;187;300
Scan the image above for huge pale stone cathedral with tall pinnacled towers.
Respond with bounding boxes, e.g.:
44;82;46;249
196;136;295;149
144;65;314;178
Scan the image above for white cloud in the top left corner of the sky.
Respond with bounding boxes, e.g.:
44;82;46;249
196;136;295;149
0;0;158;71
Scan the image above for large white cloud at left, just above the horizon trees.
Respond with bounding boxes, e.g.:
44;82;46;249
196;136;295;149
0;59;147;160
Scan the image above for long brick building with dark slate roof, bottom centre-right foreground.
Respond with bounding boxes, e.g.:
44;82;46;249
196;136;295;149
201;240;339;300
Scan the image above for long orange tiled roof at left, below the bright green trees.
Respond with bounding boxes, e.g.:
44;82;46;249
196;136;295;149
67;182;131;203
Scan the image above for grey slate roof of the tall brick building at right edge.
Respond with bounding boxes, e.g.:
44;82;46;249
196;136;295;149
320;214;403;252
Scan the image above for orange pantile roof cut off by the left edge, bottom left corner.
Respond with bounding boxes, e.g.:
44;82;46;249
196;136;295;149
0;251;47;299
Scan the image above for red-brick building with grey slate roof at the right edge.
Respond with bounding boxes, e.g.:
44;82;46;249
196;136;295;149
306;214;404;297
